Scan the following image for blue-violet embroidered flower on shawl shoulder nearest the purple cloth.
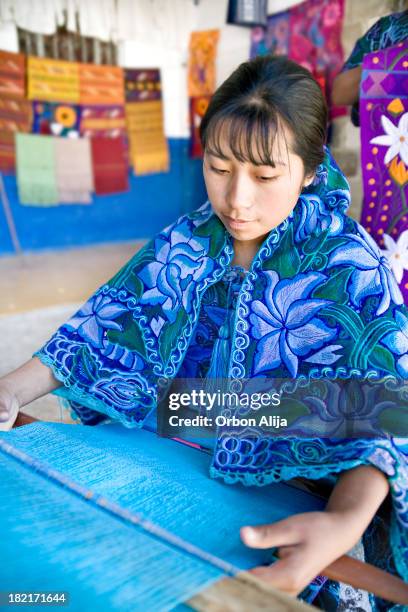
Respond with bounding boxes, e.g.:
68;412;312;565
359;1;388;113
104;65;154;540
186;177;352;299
328;226;403;315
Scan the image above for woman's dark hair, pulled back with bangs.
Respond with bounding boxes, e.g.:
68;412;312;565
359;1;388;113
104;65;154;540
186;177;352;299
200;55;327;176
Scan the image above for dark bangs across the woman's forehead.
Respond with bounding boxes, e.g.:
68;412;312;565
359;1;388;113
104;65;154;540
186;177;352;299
203;104;290;168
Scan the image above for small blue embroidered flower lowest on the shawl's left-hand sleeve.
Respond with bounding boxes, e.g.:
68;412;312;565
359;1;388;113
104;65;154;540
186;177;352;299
65;293;128;348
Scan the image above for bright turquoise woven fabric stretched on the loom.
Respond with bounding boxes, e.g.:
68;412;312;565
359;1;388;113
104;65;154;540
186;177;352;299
0;423;323;612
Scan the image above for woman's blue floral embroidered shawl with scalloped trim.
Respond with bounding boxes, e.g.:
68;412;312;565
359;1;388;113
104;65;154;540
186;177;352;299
36;150;408;609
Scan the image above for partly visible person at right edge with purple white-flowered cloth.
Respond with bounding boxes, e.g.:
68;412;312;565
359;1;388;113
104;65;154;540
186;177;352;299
333;10;408;302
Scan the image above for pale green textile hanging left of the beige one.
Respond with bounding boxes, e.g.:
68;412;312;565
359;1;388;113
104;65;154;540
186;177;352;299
16;133;58;206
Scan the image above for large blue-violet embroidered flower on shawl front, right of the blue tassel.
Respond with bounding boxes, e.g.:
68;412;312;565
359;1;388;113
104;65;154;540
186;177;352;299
249;270;336;376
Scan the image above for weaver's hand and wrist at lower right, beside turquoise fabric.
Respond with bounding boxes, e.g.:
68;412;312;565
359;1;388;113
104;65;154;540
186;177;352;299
241;465;389;595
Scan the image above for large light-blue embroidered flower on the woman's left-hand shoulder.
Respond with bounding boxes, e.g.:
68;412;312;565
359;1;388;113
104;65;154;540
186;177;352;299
138;221;214;323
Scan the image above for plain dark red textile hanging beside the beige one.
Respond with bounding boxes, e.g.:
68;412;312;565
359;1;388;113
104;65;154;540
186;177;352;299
90;137;129;195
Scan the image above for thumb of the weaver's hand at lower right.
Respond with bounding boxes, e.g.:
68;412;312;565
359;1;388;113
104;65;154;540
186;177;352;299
240;519;302;548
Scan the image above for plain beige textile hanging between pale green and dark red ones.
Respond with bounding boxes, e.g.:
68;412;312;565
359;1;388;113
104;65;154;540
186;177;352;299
55;138;93;204
